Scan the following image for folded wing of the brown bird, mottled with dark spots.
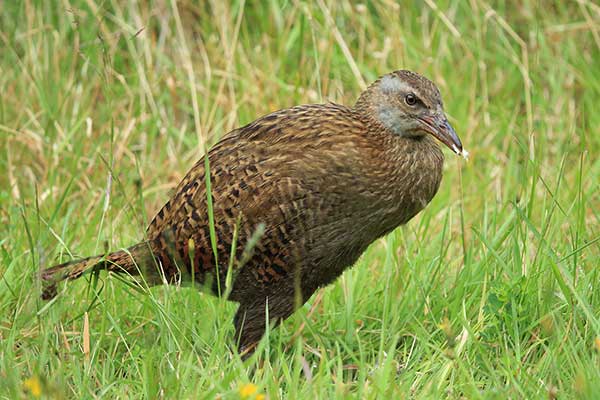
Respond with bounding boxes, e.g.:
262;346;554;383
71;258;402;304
148;105;364;288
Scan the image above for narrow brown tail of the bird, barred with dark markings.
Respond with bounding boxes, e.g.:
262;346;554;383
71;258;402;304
41;242;153;300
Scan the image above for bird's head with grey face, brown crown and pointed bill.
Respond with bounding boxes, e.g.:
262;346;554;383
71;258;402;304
357;70;466;157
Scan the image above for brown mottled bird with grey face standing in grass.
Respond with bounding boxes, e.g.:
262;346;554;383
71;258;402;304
41;70;467;356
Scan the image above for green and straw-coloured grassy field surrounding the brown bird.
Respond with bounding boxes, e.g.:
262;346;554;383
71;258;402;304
0;0;600;399
